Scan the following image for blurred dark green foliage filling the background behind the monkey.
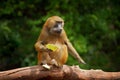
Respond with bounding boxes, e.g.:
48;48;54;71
0;0;120;71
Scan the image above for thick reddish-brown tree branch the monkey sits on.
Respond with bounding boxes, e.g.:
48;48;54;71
0;65;120;80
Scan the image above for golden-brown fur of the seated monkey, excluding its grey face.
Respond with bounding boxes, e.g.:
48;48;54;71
35;16;84;66
